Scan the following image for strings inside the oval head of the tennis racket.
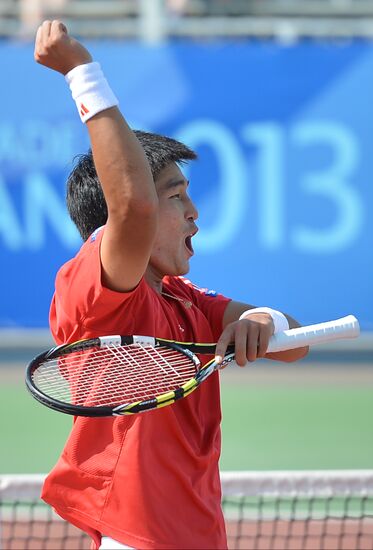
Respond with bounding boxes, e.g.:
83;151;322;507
33;344;196;406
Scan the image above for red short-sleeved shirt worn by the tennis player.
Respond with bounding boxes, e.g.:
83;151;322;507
42;226;229;549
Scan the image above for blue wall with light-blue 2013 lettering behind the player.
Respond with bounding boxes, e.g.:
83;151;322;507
0;42;373;330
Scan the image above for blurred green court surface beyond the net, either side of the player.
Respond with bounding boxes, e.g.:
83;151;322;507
0;362;373;473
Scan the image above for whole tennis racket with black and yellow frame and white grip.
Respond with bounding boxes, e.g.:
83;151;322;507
26;315;359;417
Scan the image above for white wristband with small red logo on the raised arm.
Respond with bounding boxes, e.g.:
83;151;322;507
65;61;119;122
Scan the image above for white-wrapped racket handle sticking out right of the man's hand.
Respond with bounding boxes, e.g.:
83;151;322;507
267;315;360;353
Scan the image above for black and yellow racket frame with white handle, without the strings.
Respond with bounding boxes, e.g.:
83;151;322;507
26;315;360;417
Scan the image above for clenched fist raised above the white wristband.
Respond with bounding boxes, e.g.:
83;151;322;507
34;20;92;75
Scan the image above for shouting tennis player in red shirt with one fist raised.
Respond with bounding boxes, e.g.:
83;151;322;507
35;21;307;549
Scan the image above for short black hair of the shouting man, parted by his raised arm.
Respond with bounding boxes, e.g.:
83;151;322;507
66;130;197;241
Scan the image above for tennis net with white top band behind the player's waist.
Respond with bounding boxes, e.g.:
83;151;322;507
0;470;373;550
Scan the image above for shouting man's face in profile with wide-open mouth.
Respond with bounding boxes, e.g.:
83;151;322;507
149;164;198;277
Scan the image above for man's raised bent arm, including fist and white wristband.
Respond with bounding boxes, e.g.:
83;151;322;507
35;21;158;291
